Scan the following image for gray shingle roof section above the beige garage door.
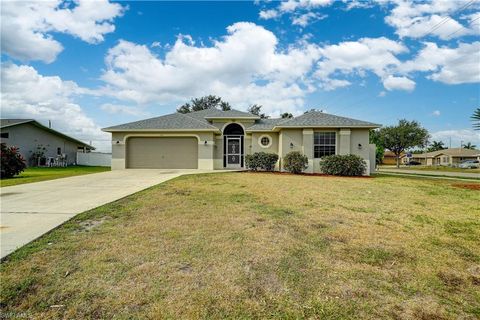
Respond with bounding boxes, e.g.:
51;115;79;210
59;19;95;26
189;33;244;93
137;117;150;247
102;113;218;131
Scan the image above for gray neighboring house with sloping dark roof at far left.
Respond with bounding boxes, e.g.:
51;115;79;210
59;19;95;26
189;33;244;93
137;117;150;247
0;119;95;165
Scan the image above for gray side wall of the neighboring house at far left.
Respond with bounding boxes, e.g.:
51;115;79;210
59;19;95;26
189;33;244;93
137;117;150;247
1;123;80;165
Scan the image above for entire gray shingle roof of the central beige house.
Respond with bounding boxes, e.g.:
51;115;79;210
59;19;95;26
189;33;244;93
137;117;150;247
102;108;380;132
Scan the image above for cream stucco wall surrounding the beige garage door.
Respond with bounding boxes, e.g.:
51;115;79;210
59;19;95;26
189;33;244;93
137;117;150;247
112;131;215;170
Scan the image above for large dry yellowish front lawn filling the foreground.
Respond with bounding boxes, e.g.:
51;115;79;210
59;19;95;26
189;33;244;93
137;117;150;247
0;173;480;319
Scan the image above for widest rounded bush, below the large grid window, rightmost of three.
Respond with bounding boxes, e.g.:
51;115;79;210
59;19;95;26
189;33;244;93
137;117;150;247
320;154;367;176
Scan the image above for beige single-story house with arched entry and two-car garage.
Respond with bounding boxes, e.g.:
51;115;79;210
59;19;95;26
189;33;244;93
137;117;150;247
102;108;379;174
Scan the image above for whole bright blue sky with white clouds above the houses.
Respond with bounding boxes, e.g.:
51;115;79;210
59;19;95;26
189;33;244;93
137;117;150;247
2;0;480;150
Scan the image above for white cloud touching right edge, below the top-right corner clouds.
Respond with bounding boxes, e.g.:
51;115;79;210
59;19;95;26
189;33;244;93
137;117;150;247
399;41;480;84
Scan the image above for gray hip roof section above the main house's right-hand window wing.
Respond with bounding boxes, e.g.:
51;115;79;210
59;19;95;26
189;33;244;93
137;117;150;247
278;111;380;128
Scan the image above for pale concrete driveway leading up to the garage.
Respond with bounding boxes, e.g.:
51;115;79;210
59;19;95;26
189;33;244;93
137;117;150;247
0;169;225;258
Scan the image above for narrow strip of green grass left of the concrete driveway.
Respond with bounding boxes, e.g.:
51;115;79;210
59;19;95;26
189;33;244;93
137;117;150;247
0;166;110;187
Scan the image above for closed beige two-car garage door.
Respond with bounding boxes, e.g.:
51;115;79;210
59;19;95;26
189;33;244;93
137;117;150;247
126;137;198;169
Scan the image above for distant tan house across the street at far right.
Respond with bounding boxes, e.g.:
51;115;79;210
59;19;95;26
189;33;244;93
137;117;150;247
402;148;479;166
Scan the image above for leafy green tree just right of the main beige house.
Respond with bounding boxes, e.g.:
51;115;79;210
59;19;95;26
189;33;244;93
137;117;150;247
378;119;429;168
